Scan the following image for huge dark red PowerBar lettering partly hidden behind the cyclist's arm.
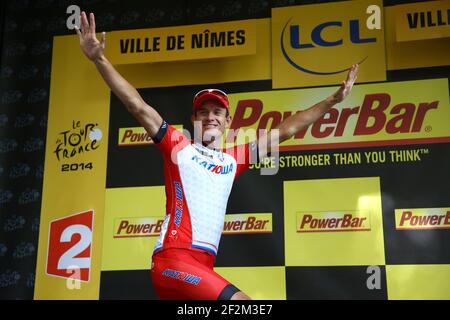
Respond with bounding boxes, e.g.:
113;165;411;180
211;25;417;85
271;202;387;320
227;93;445;150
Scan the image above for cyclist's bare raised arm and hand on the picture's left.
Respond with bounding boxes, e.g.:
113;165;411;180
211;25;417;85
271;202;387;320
75;12;163;137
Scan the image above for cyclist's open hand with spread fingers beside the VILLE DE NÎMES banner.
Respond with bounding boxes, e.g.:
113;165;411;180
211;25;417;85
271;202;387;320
75;11;106;62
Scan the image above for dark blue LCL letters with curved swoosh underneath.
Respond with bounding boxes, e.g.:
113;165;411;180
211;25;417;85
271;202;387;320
280;9;379;75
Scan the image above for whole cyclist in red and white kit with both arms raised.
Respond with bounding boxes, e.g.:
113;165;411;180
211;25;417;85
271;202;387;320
75;12;358;300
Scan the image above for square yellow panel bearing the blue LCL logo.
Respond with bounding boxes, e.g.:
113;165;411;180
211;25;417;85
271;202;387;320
272;0;386;88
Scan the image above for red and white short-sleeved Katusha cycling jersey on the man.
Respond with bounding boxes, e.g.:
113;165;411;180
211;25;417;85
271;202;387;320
154;122;256;255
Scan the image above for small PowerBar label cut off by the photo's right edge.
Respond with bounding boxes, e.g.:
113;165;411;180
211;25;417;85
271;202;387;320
395;208;450;230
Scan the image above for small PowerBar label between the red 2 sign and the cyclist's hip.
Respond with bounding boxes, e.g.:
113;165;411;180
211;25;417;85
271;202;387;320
113;217;164;238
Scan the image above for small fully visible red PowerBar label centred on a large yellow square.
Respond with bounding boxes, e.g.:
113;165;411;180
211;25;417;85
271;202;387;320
297;211;370;232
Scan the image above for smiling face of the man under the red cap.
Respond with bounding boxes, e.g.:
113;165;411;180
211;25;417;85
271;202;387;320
191;100;231;142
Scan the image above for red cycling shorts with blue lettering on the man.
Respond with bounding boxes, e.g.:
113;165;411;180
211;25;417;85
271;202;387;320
151;248;240;300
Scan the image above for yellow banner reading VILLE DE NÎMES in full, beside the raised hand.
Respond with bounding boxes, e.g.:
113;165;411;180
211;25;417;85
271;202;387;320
106;20;256;65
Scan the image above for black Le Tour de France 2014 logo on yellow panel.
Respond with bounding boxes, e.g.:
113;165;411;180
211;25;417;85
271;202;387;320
53;121;103;172
